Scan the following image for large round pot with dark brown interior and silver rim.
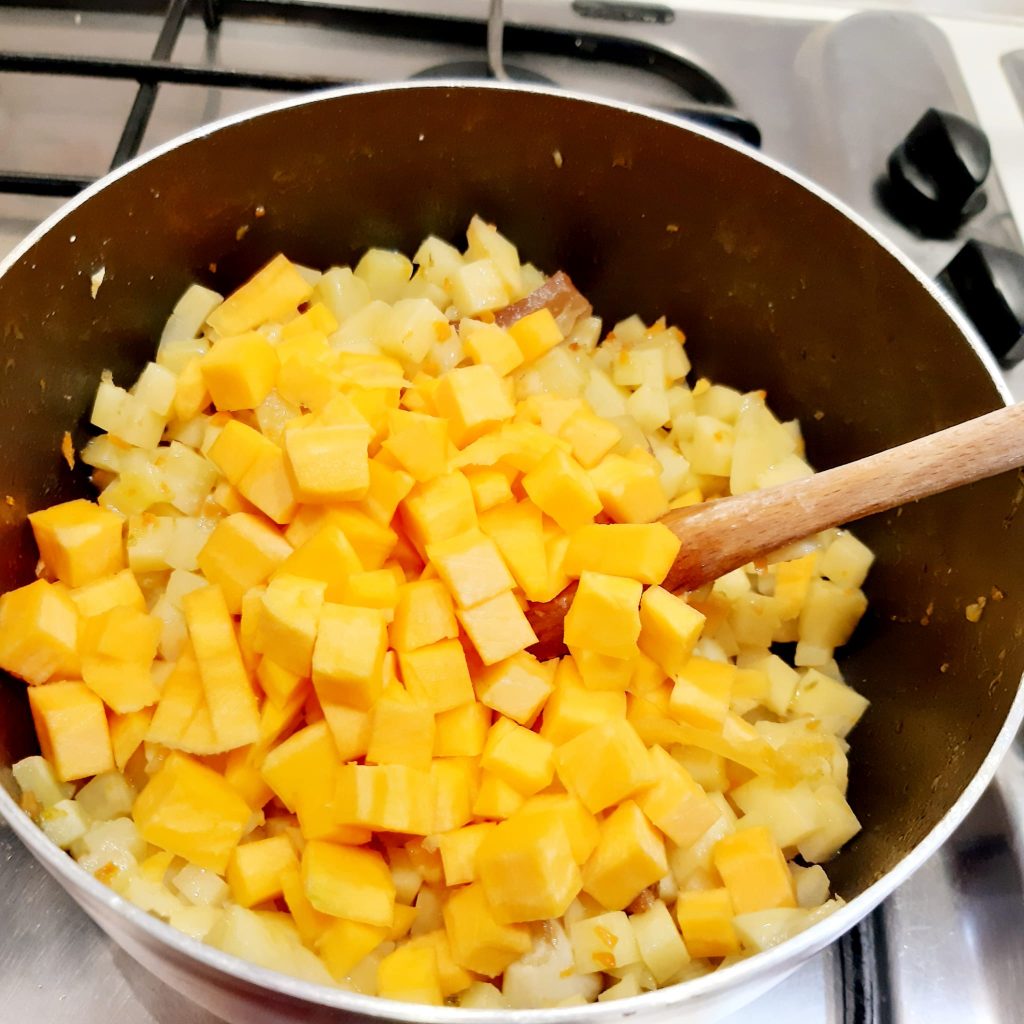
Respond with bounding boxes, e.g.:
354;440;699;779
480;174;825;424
0;83;1024;1024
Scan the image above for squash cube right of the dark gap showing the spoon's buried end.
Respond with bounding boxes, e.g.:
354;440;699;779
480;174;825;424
564;572;643;659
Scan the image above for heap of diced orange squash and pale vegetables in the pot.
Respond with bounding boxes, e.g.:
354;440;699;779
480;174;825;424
0;218;871;1008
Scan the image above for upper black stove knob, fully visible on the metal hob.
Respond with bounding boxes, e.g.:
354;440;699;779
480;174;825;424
886;108;992;234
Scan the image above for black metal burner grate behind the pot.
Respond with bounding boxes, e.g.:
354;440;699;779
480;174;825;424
0;0;760;197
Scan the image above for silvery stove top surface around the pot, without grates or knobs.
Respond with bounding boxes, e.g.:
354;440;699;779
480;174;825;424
0;0;1024;1024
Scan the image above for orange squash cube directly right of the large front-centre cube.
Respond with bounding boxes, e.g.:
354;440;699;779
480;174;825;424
583;800;669;910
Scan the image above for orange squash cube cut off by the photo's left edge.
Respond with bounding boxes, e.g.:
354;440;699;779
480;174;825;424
0;580;80;685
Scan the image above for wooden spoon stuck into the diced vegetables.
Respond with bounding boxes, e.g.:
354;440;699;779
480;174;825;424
526;403;1024;656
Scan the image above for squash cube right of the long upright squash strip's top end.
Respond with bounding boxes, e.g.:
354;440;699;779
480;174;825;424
253;572;327;677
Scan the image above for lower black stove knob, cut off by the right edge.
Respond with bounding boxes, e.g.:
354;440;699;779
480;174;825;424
938;241;1024;367
